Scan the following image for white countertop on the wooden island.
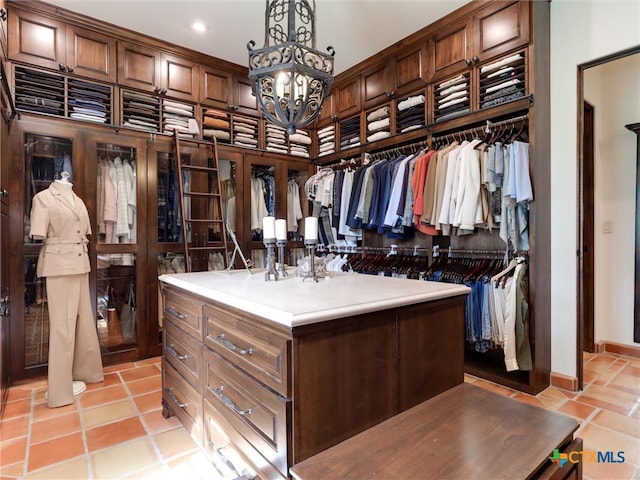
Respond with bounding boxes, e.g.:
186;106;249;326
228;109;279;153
159;270;470;327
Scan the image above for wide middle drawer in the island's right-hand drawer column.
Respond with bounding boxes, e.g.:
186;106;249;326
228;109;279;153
203;348;290;476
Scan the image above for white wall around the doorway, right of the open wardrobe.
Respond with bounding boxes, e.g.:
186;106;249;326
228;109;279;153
550;0;640;377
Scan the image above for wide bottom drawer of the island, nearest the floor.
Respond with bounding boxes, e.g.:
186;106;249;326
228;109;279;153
203;399;289;479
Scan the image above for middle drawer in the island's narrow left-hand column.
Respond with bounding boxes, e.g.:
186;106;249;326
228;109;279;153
164;321;202;393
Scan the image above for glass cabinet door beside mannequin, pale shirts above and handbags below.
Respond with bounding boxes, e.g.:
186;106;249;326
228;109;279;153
91;139;142;357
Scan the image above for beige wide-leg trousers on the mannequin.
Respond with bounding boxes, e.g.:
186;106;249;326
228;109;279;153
46;273;104;408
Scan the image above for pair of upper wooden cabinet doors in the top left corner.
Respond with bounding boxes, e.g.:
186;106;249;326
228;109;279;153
8;8;117;82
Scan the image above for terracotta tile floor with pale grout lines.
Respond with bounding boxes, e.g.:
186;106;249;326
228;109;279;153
0;353;640;480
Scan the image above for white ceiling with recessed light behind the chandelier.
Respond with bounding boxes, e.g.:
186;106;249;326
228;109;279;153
46;0;469;74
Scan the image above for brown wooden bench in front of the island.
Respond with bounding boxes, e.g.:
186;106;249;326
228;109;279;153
290;383;582;480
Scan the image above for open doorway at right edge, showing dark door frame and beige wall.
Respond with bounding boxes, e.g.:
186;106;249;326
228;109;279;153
576;46;640;390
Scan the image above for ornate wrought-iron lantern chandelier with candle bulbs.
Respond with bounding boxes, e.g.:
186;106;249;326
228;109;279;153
247;0;335;135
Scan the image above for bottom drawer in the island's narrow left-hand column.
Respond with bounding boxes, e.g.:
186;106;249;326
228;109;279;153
162;359;202;444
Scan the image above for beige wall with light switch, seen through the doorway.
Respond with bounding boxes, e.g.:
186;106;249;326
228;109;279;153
584;54;640;345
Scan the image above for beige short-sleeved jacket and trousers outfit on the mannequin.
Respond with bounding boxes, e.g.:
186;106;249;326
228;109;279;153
29;181;104;408
